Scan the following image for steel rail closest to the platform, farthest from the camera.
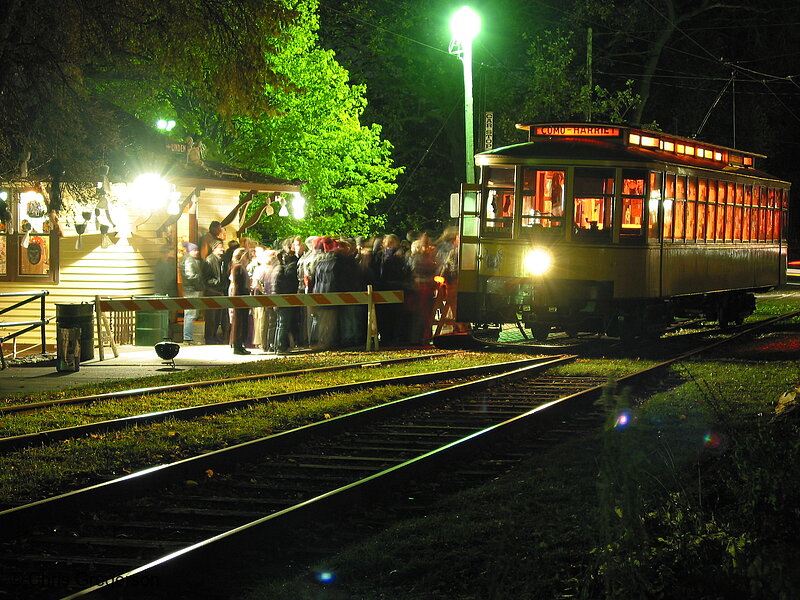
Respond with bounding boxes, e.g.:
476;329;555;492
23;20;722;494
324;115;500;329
0;352;453;415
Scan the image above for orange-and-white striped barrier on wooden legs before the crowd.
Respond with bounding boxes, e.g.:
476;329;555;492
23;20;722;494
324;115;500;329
95;286;404;360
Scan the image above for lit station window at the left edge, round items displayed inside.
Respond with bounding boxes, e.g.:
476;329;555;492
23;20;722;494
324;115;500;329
0;189;58;283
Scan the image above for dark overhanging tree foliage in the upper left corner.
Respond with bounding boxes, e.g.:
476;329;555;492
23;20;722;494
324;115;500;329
0;0;298;179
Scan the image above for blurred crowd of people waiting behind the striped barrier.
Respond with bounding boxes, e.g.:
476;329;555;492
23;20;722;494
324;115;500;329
159;221;456;354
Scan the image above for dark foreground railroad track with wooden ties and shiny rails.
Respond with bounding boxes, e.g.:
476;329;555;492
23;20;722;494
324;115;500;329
0;313;797;600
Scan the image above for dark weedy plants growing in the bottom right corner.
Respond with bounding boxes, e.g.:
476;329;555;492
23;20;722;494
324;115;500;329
584;363;800;599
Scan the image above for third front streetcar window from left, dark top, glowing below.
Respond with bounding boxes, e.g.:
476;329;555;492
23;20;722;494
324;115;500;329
573;169;614;238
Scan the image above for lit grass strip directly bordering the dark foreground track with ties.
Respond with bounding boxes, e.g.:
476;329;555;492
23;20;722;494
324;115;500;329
0;386;419;506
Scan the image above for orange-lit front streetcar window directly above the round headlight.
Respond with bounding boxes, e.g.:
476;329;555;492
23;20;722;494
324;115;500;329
521;168;566;231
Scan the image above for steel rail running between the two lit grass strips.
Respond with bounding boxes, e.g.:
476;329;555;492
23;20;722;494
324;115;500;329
0;356;564;453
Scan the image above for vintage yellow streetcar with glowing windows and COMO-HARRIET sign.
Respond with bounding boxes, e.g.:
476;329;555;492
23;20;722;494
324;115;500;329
454;123;790;341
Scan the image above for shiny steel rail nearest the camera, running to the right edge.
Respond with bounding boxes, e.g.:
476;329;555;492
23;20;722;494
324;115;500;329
50;311;800;600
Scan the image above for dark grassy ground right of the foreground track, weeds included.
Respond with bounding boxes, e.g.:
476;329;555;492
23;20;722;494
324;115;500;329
246;359;800;600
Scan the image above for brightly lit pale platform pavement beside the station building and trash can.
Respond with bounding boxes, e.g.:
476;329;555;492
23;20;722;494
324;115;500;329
0;345;284;399
